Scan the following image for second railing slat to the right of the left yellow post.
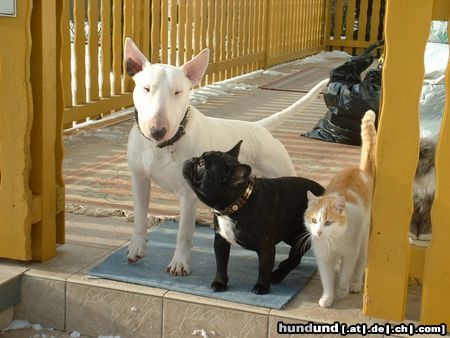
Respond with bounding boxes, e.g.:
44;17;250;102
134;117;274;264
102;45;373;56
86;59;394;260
73;0;86;104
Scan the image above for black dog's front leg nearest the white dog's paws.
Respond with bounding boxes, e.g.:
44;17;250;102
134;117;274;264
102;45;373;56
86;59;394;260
211;231;230;292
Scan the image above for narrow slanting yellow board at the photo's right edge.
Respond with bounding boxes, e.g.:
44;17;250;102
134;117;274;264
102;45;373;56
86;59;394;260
421;11;450;327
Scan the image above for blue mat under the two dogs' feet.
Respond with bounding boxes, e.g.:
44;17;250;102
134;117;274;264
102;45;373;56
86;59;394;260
90;221;317;309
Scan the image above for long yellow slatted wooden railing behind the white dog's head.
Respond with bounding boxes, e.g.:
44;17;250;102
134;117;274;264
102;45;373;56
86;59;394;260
60;0;326;128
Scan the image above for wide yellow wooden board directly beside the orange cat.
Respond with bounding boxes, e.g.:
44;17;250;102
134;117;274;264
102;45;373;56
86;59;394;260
364;0;432;320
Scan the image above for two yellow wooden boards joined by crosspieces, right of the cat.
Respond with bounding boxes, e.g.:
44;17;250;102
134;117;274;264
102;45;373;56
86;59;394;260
364;0;450;327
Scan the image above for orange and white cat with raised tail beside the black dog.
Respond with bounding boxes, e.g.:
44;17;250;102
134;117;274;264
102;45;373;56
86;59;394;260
305;110;376;307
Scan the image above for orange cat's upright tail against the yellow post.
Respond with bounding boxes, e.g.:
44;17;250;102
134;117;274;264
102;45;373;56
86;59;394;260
359;110;377;177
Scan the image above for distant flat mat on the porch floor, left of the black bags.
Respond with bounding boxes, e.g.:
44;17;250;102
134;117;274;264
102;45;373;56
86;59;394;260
260;65;331;93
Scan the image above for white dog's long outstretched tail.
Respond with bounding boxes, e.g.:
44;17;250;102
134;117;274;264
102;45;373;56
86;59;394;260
256;79;330;131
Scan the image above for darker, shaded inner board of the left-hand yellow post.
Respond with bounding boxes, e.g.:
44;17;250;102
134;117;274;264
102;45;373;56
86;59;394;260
30;0;61;261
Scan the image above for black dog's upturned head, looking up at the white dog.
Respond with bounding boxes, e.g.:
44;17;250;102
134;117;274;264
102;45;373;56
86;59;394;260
183;140;252;210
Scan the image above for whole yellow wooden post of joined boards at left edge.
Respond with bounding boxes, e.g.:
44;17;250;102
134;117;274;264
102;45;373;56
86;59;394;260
0;0;64;260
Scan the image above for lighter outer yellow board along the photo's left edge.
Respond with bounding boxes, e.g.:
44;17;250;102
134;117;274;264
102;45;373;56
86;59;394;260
0;0;33;260
